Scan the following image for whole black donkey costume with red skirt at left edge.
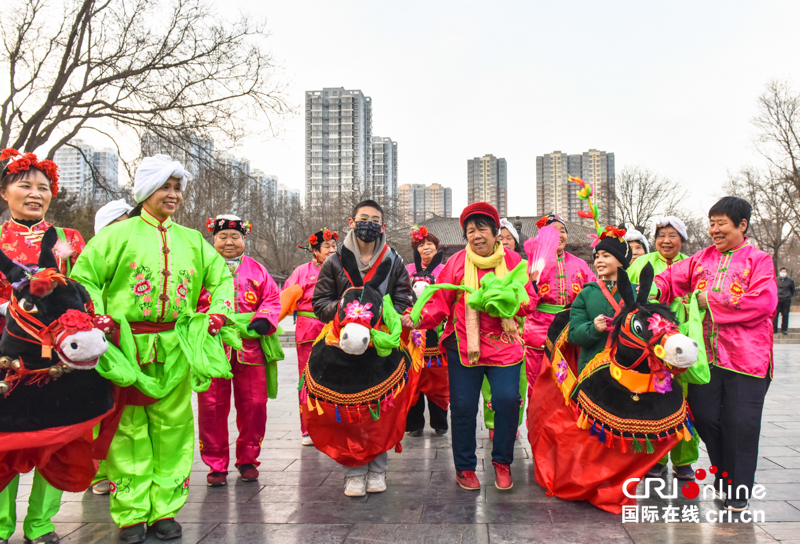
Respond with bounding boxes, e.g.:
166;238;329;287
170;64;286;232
0;227;114;492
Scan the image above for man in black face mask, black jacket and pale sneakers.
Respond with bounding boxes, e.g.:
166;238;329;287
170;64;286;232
312;200;411;497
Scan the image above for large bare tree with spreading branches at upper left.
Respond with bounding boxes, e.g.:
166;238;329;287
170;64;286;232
0;0;291;189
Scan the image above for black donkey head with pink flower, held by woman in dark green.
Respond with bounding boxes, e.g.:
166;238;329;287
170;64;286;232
610;264;698;383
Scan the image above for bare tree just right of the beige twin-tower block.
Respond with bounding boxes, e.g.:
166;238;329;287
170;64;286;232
614;166;687;232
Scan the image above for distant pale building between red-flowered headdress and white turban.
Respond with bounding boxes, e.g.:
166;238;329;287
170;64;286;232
53;140;119;204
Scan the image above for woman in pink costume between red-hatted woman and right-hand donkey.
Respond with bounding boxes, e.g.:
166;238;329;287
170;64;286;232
522;214;597;399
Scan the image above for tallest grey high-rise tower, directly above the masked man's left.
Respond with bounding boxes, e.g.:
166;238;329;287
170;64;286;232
306;87;372;205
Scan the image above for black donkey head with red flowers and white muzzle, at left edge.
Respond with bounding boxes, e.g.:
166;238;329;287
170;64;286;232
0;227;108;395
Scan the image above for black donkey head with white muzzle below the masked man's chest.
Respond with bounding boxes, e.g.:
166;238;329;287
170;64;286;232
333;246;392;355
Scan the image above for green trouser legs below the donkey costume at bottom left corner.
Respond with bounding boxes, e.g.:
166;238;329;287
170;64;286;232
0;470;64;540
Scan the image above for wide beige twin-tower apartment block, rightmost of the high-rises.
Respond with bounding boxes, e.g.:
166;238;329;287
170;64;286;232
536;149;616;226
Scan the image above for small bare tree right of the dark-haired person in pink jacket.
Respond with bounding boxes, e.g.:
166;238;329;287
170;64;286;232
724;168;794;272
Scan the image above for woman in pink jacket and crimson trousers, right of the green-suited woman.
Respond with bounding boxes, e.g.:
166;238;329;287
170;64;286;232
197;215;281;487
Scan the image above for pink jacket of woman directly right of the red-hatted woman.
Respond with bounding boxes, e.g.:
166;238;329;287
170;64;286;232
522;251;597;349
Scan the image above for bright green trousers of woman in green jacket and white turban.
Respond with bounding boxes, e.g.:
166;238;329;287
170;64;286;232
106;378;194;527
